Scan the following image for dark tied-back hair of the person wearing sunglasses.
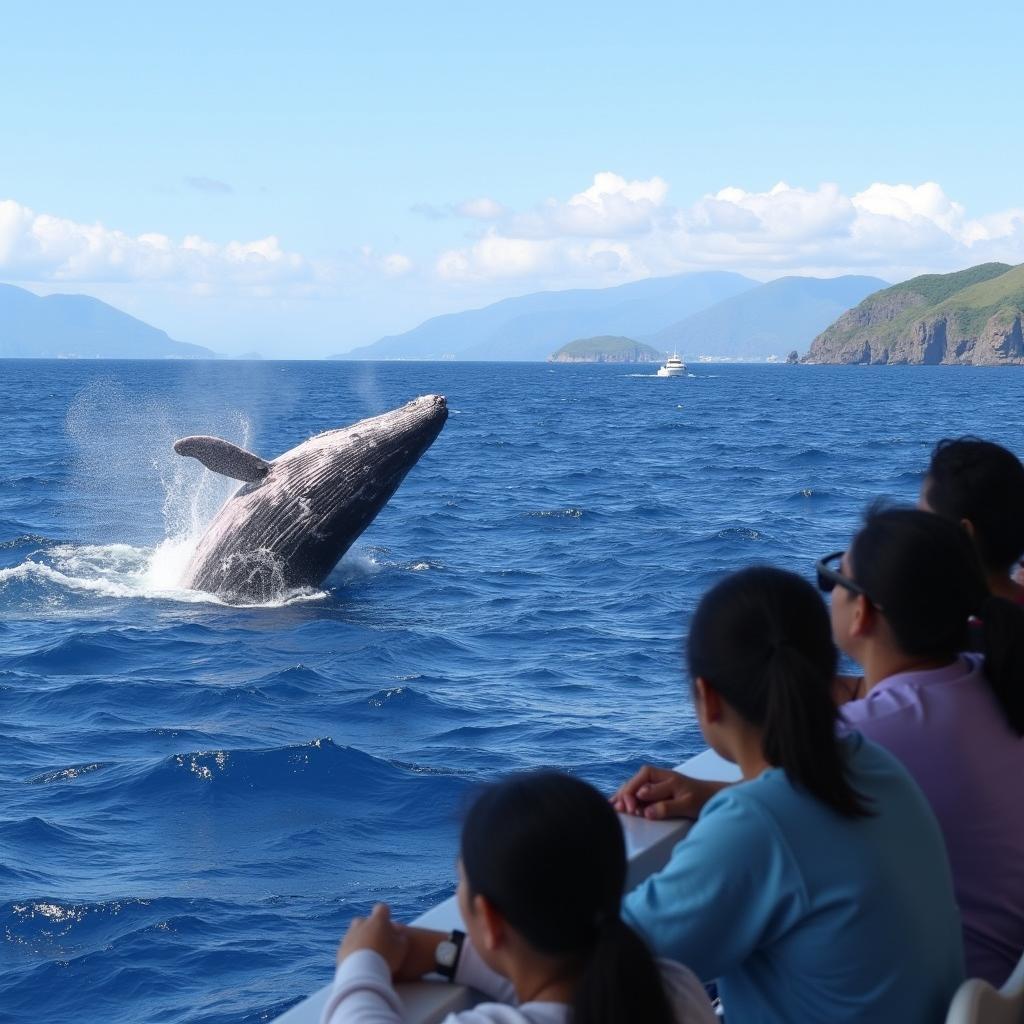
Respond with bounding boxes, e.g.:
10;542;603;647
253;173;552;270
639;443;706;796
850;507;1024;734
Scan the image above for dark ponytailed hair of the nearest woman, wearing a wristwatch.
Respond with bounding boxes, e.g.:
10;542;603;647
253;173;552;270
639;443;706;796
461;771;674;1024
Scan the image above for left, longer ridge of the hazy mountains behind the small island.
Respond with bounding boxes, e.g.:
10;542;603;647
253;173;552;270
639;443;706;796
337;271;758;359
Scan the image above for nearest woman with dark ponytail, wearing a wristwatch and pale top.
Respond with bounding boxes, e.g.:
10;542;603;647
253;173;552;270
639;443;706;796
323;772;716;1024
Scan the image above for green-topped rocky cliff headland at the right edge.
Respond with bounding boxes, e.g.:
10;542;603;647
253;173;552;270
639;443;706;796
807;263;1024;366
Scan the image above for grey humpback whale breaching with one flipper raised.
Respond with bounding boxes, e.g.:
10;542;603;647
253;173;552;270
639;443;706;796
174;394;447;603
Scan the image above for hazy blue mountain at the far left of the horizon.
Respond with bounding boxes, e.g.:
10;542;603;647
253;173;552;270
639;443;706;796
0;285;216;359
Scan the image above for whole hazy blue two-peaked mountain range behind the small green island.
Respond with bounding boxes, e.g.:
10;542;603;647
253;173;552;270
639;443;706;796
337;271;886;360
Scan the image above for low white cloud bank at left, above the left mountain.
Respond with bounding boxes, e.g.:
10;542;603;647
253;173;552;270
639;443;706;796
0;200;313;287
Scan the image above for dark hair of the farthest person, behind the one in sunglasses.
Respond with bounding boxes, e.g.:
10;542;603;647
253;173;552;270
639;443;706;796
925;437;1024;572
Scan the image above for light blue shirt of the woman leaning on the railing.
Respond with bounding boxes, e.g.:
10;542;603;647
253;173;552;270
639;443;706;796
624;734;964;1024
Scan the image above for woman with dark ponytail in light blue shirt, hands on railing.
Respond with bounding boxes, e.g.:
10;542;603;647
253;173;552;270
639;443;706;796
612;567;965;1024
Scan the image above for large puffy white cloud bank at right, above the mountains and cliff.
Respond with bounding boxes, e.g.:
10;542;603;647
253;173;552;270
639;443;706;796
435;172;1024;288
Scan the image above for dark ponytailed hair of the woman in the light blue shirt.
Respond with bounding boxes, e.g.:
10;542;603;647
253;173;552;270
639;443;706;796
688;566;867;817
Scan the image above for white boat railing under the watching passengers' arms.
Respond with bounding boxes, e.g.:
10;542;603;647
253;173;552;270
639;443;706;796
274;751;739;1024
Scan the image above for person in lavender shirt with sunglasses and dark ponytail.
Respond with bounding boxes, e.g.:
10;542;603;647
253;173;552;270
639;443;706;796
818;509;1024;985
